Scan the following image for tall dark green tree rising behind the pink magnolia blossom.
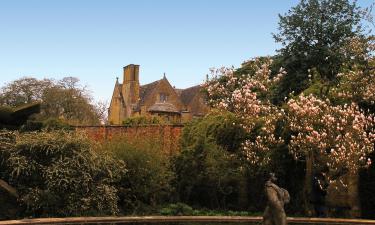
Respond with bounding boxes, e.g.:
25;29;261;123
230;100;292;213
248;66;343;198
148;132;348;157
274;0;364;101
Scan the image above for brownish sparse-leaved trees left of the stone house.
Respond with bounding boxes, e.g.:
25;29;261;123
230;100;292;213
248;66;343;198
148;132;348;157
0;77;104;125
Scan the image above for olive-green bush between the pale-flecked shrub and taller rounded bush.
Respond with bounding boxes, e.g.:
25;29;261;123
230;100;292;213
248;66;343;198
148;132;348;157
99;137;174;214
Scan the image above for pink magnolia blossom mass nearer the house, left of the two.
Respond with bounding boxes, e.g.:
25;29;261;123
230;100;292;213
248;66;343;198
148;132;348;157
204;58;285;165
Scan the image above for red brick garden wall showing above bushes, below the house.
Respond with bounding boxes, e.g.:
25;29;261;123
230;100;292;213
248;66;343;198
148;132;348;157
75;125;183;154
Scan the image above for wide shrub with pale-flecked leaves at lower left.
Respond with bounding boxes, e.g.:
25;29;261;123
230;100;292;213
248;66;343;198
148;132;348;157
0;131;126;217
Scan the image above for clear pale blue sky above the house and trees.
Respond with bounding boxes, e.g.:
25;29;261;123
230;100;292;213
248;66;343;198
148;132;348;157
0;0;373;100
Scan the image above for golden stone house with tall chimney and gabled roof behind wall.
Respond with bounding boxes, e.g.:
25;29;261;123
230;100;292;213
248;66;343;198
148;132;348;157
108;64;209;125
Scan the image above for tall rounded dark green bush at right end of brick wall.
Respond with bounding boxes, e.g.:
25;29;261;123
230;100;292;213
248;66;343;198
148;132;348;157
174;113;246;209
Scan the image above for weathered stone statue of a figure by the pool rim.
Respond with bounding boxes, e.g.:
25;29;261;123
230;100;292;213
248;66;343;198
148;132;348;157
263;173;290;225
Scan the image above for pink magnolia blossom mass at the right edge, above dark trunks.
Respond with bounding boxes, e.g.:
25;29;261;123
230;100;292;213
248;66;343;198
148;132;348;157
287;95;375;180
